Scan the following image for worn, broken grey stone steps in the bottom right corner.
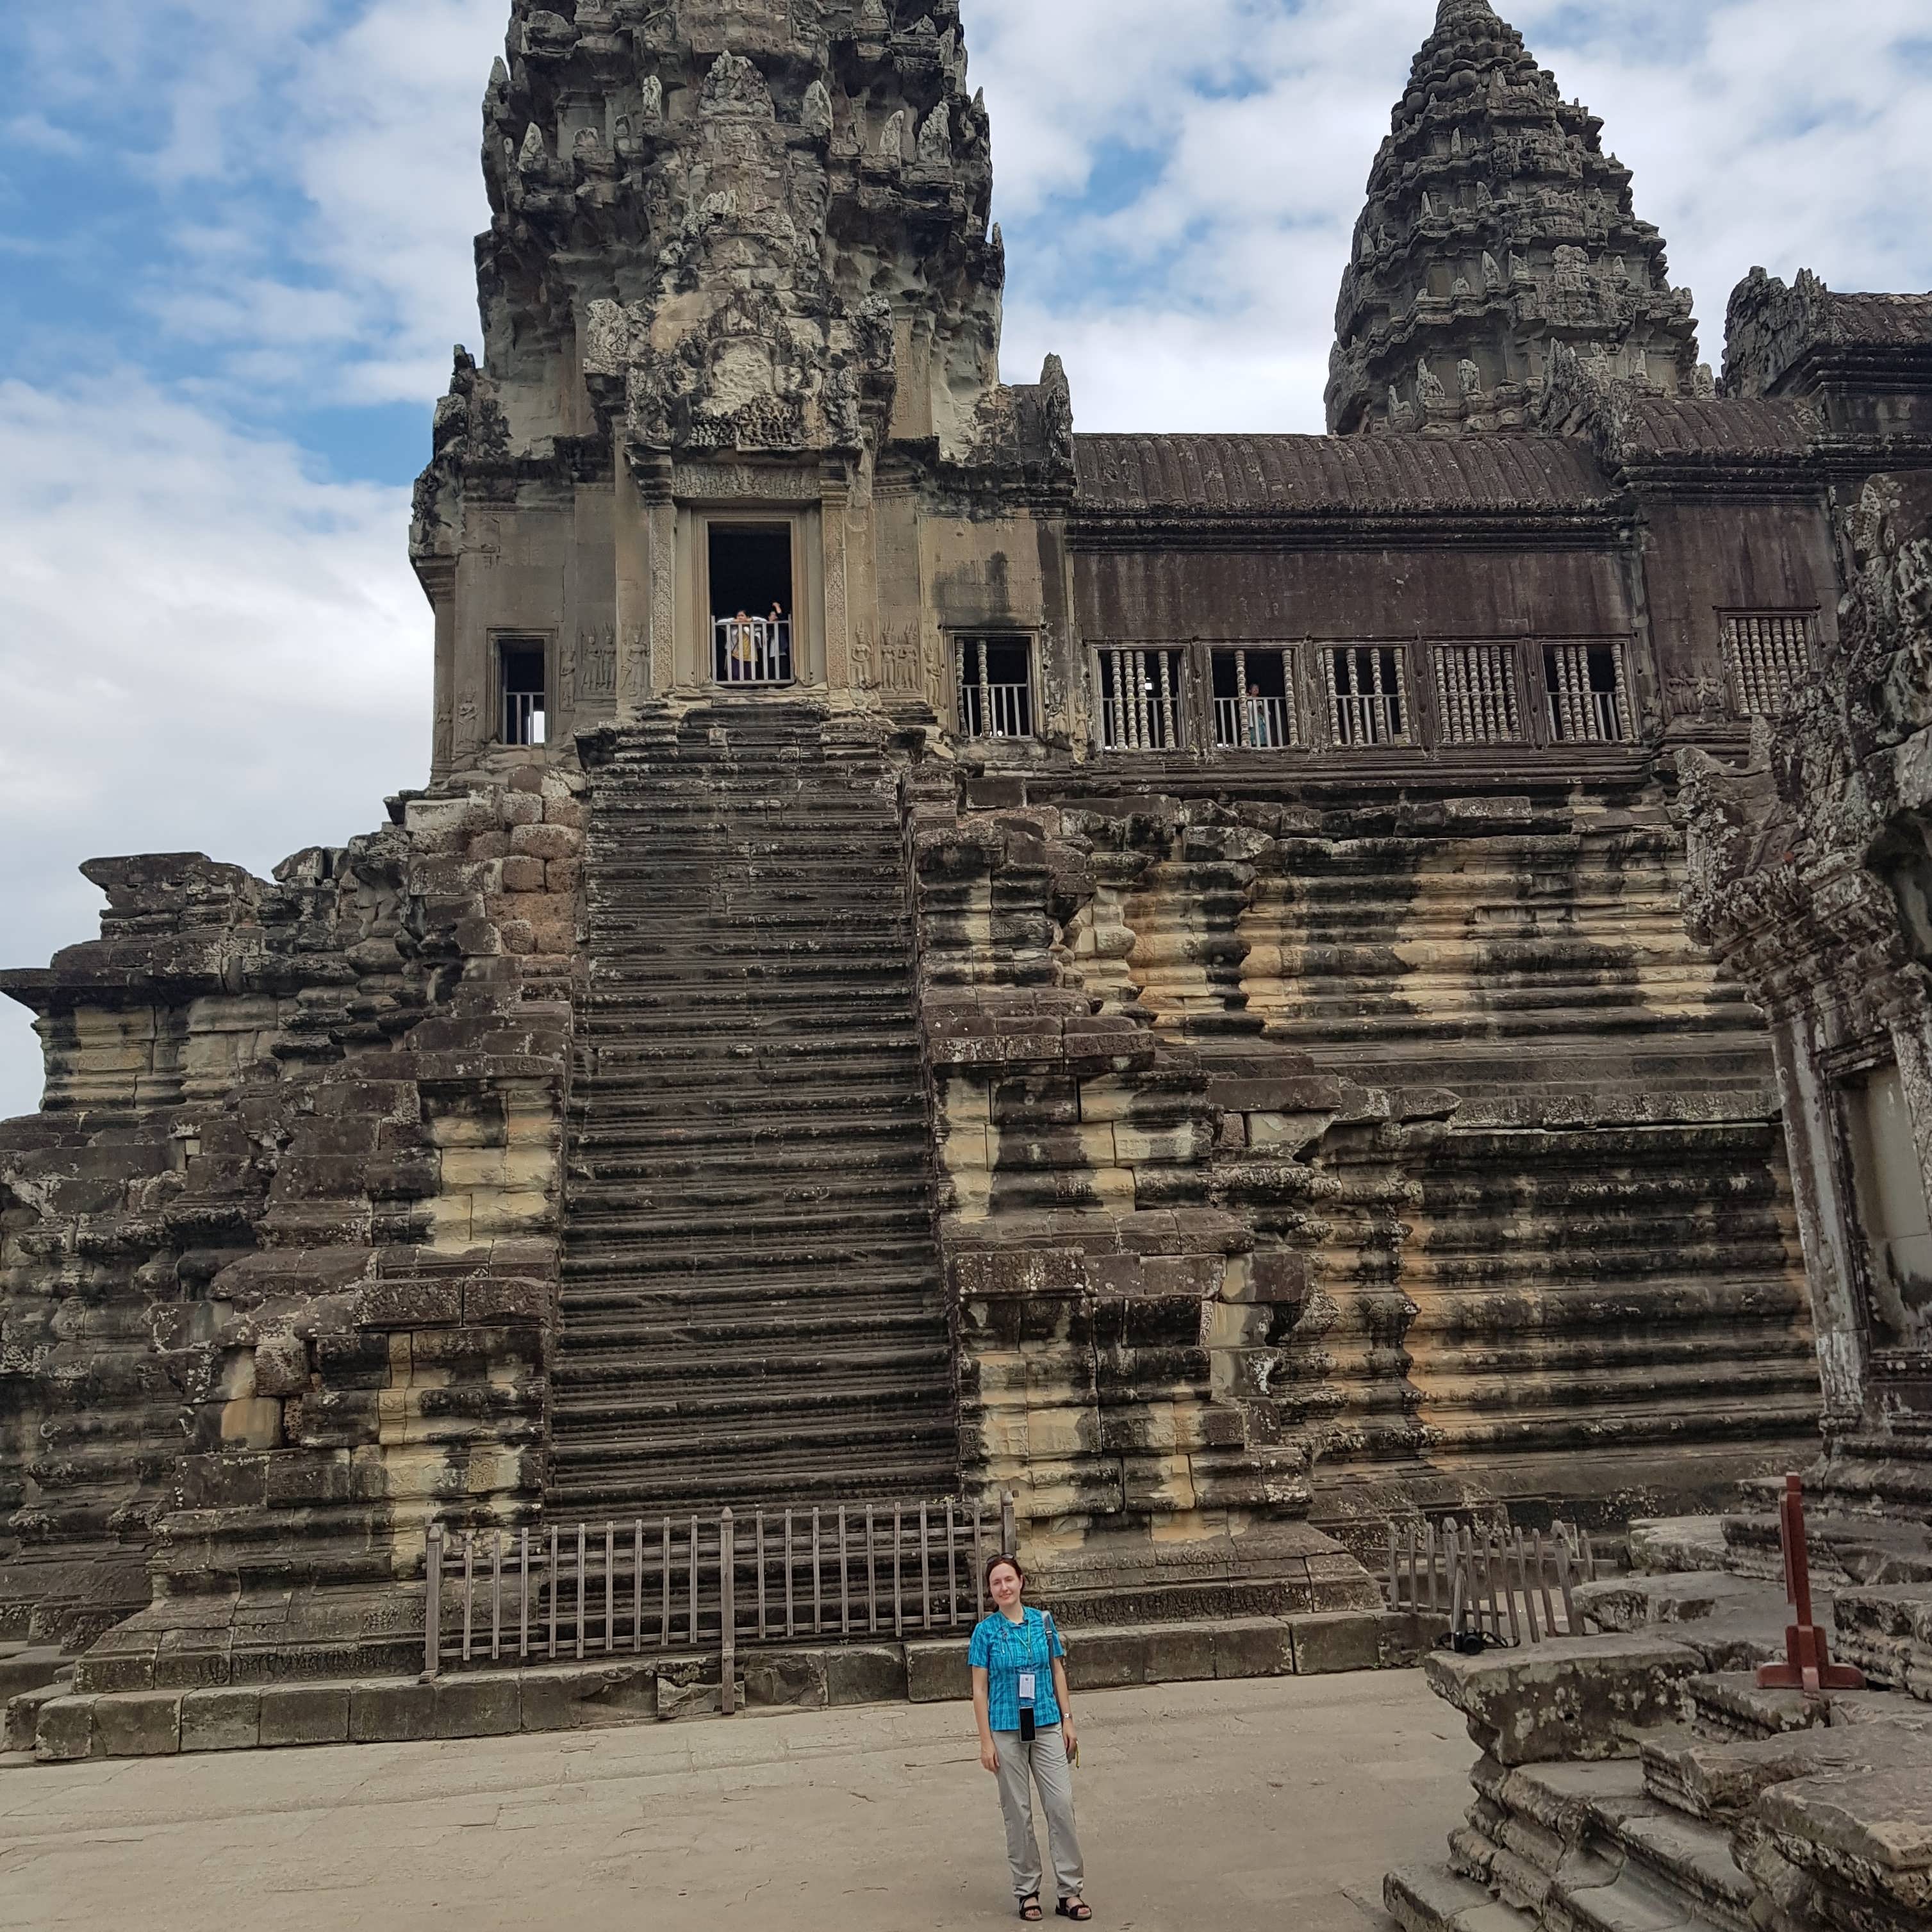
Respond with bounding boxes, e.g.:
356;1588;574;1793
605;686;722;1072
1385;1573;1932;1932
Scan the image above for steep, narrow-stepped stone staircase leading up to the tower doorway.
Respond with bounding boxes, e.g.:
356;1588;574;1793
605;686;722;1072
549;703;958;1517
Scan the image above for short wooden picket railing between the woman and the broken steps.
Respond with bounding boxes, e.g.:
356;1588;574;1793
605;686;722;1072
1387;1519;1596;1644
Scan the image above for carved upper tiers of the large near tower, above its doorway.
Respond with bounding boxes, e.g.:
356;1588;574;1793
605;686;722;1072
442;0;1005;479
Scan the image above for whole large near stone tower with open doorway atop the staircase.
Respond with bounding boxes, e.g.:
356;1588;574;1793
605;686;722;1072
413;0;1072;771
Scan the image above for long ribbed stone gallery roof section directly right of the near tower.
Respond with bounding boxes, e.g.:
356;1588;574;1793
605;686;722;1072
1074;436;1609;516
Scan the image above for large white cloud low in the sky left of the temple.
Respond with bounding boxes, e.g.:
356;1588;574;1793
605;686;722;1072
0;375;431;1117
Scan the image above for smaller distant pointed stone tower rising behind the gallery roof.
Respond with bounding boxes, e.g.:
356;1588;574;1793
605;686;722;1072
1327;0;1708;434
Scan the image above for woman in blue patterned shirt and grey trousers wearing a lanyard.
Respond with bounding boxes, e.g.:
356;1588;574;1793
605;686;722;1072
970;1557;1093;1922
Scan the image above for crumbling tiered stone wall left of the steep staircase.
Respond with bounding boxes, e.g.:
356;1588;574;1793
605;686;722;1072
0;767;582;1669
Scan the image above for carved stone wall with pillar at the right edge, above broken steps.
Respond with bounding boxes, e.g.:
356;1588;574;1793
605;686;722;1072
1681;477;1932;1519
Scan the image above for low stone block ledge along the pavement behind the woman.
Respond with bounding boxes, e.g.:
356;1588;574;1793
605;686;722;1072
0;1612;1439;1764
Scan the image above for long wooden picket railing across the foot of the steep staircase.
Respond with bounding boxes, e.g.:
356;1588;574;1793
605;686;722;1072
423;1496;1014;1708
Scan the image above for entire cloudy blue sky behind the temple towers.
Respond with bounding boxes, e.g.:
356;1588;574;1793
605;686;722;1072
0;0;1932;1117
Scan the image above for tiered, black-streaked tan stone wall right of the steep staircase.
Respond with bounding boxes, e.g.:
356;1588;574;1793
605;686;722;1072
920;761;1816;1542
